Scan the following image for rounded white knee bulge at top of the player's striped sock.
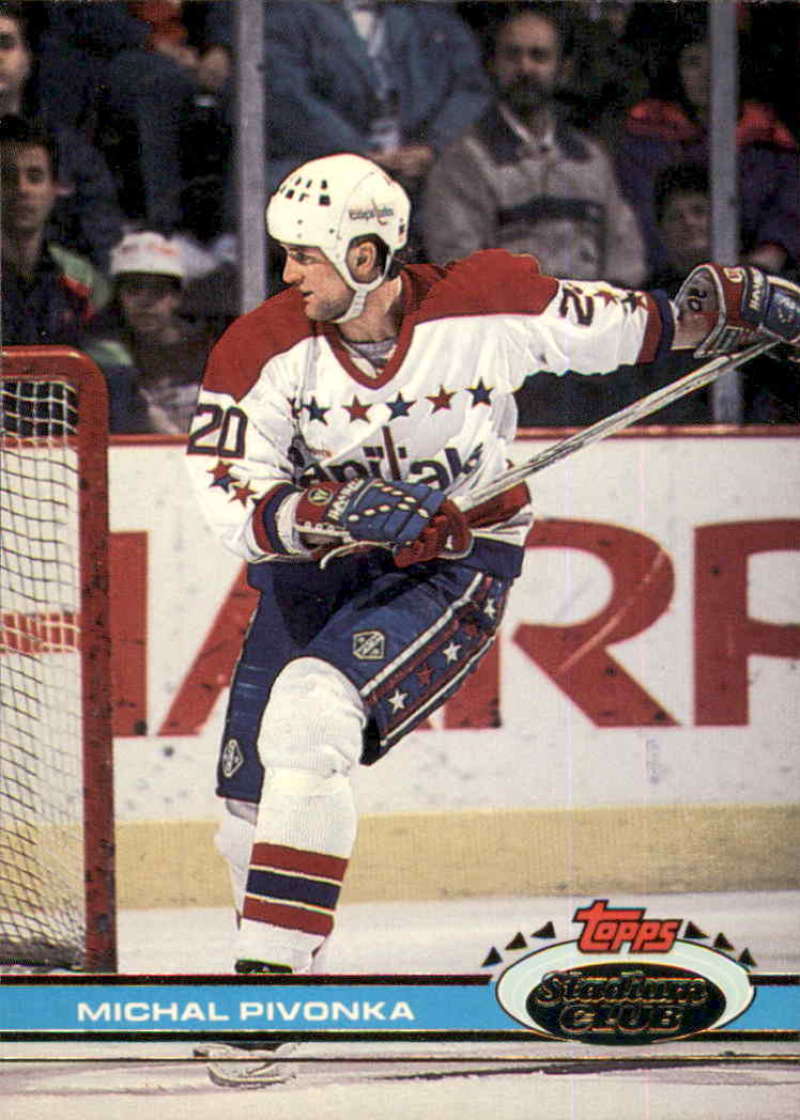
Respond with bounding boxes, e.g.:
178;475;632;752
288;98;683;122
259;657;365;776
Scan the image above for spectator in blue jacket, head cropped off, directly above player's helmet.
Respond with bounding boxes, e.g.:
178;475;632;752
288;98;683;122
258;0;489;208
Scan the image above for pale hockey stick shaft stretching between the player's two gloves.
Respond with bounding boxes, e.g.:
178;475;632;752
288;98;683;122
454;338;779;513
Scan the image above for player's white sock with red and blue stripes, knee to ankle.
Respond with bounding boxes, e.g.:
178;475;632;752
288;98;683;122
236;657;364;972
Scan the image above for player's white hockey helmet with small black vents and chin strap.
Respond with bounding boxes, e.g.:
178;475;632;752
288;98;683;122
267;152;411;323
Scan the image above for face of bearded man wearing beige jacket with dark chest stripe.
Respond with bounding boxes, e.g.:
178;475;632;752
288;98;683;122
492;13;560;112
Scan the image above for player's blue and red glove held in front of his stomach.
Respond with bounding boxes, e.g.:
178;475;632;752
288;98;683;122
295;478;445;547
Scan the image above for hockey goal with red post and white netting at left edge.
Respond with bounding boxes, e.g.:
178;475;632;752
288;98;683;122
0;347;115;971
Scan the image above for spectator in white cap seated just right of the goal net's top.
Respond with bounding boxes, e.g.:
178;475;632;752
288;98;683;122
84;232;213;433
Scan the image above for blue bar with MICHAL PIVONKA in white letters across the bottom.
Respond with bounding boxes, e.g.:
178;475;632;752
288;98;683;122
0;974;800;1045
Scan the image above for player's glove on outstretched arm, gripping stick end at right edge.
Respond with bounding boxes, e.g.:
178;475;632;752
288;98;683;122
676;264;800;355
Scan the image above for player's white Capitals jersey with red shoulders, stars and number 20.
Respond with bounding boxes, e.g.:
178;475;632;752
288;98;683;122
188;250;671;562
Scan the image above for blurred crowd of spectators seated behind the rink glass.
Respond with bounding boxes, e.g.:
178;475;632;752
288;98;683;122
0;0;800;432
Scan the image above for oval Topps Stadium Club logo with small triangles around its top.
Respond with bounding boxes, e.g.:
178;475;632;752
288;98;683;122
484;898;755;1046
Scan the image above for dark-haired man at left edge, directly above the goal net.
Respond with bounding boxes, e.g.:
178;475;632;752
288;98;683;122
0;116;108;346
